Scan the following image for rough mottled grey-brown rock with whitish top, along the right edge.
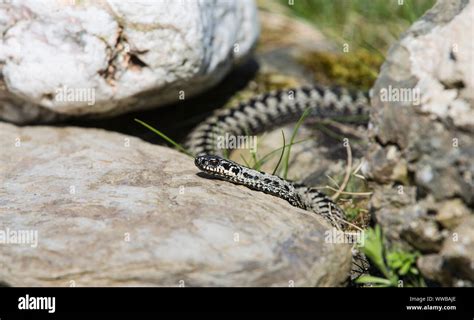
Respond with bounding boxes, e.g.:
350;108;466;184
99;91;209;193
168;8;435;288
364;0;474;286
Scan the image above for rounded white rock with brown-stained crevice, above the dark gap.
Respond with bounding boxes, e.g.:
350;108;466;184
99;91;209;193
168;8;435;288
0;0;259;123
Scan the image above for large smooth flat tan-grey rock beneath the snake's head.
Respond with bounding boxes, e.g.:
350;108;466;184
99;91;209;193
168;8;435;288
0;123;351;286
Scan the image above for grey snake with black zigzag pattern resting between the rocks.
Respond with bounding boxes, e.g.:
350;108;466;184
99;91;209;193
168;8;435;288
186;86;369;229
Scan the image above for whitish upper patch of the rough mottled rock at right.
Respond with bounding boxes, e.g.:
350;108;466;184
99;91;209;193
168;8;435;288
401;2;474;128
